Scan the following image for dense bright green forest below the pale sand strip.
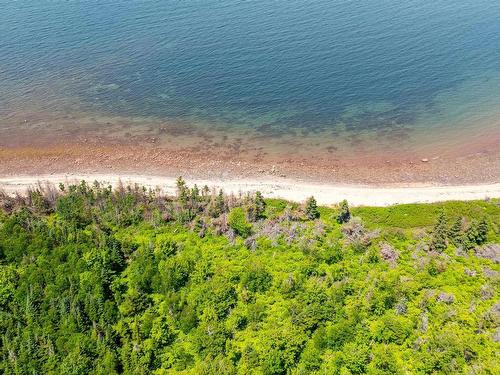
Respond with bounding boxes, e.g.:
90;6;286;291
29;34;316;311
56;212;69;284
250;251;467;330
0;179;500;374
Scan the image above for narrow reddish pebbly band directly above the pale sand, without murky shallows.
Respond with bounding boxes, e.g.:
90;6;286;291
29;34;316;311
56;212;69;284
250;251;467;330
0;142;500;186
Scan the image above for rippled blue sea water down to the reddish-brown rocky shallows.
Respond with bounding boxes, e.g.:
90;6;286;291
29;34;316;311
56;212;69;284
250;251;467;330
0;0;500;155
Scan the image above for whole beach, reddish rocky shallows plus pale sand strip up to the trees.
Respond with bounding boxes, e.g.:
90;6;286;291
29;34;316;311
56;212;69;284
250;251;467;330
0;110;500;206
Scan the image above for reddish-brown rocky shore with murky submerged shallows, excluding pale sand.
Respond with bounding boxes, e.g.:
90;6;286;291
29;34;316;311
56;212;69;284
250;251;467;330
0;108;500;185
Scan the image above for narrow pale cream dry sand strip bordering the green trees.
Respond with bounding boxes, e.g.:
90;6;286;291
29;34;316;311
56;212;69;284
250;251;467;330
0;173;500;206
